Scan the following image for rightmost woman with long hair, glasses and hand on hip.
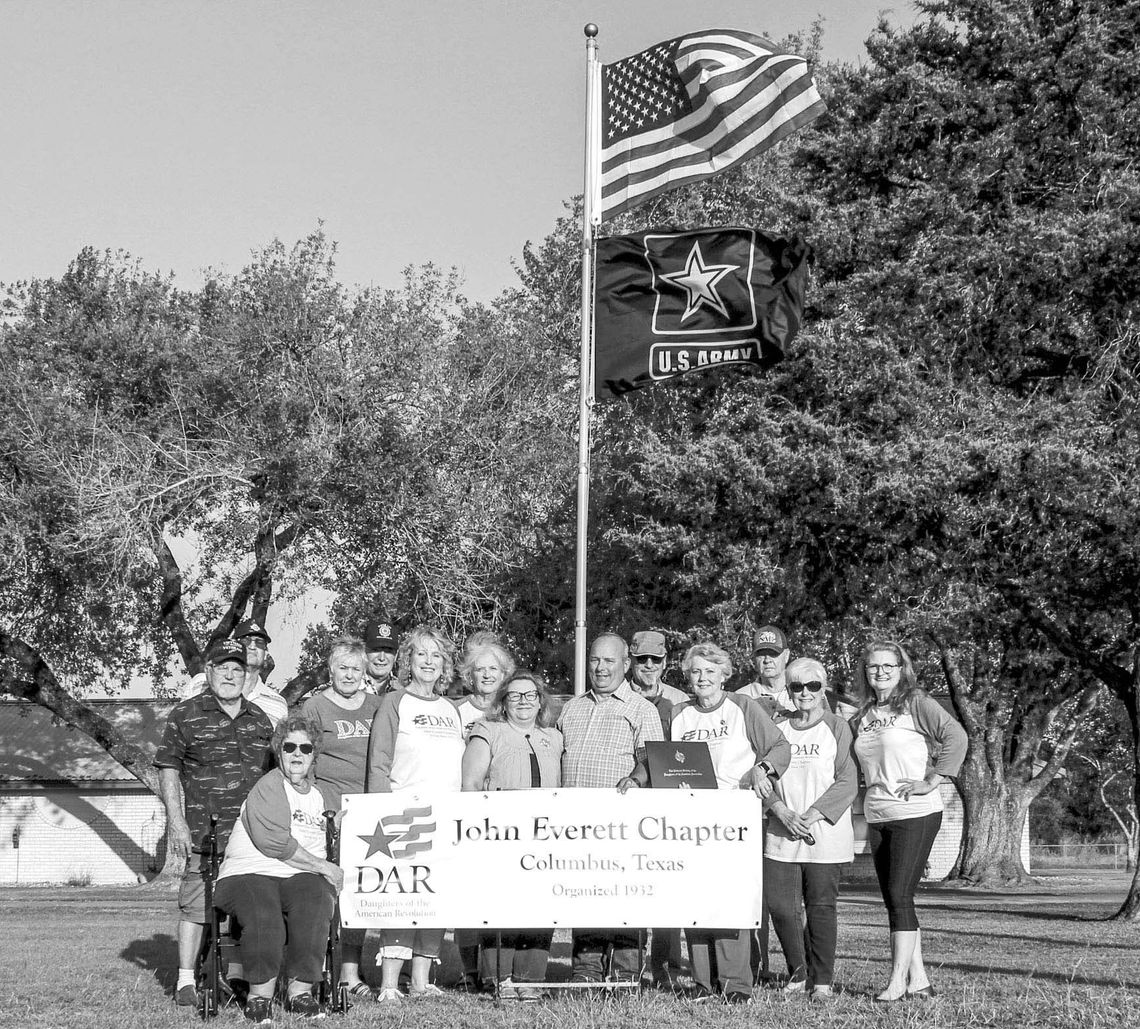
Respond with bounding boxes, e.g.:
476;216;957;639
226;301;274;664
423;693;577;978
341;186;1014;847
852;640;967;1003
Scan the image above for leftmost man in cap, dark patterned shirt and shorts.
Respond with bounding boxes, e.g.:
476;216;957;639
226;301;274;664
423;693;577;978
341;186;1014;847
154;639;272;1006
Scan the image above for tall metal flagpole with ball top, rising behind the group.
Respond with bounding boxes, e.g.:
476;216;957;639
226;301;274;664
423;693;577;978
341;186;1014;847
573;22;602;696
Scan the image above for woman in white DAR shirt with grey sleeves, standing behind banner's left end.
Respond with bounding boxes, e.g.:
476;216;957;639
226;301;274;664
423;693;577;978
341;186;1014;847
368;626;463;1004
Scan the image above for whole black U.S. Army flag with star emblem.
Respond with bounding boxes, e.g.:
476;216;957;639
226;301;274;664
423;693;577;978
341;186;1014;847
594;228;809;399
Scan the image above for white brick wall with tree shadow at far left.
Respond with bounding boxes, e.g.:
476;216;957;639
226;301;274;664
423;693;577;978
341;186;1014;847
0;787;166;885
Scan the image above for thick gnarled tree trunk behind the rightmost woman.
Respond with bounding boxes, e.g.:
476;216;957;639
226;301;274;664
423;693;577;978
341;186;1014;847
950;759;1033;887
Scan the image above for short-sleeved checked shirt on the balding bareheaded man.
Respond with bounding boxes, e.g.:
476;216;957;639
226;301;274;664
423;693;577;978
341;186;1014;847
557;680;665;787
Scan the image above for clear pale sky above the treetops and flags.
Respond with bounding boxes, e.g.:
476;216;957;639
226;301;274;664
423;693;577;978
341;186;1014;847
0;0;912;300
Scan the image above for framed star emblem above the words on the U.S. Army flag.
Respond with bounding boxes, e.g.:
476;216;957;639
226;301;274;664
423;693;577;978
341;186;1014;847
644;229;757;336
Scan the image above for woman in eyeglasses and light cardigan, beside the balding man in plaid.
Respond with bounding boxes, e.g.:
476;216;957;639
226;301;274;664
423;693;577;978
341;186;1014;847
463;671;562;1002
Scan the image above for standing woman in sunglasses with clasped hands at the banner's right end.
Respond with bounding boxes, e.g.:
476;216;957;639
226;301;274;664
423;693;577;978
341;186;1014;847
764;658;858;1002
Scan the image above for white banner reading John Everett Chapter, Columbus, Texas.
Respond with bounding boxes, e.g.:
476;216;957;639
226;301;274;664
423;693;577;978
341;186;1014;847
341;789;764;929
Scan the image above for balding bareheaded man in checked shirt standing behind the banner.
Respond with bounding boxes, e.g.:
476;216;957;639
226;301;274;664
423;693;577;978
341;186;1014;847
557;632;665;982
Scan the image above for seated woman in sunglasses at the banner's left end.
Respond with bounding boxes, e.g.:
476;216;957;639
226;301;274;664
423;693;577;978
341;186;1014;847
214;714;344;1024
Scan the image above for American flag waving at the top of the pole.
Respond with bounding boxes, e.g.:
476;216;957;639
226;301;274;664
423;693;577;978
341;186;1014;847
595;28;823;218
